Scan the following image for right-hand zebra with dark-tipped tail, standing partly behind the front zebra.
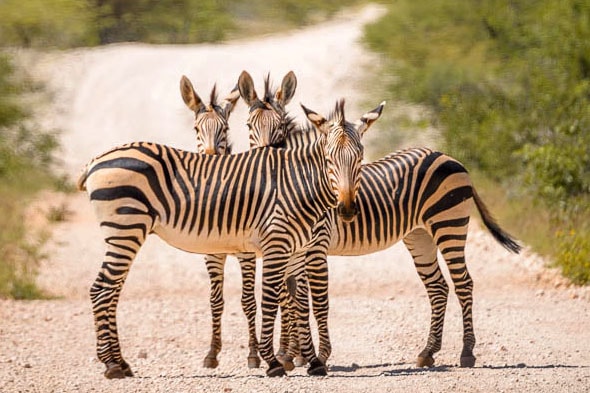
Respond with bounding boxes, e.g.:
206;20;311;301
242;76;521;367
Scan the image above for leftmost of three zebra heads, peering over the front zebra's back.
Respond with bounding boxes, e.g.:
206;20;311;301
180;75;240;155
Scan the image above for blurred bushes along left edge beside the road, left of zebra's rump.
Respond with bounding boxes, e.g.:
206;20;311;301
0;55;57;299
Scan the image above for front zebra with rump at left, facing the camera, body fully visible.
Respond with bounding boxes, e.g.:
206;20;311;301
77;93;382;378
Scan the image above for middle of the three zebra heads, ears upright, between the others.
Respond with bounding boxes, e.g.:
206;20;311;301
238;71;297;148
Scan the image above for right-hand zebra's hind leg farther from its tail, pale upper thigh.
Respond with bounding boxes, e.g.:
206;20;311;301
403;229;449;367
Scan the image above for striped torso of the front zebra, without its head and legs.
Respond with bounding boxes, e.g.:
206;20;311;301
79;139;344;253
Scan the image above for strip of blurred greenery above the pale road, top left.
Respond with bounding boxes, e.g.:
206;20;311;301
0;0;360;48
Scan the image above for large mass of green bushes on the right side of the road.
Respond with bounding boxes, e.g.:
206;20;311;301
365;0;590;283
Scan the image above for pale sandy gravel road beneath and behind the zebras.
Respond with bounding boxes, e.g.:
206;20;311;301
0;3;590;392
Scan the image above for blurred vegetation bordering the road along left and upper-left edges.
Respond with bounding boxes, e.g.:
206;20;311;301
0;0;359;299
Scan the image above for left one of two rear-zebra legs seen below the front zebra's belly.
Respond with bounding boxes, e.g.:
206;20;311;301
203;254;227;368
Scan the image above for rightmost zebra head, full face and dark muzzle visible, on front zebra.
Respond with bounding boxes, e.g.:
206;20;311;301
301;99;385;222
